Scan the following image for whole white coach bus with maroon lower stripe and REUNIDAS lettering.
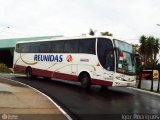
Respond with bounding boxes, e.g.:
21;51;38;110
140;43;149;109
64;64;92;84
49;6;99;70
13;36;136;88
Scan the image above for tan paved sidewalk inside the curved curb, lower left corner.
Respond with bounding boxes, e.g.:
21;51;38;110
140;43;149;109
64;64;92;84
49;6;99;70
0;78;67;120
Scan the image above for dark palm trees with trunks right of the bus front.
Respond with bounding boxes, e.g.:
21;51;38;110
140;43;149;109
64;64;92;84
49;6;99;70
132;35;160;92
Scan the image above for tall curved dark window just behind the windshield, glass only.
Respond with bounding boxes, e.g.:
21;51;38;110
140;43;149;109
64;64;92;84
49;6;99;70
97;38;115;71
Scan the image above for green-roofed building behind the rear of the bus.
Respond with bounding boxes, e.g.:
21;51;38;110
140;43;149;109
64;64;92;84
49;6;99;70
0;36;62;67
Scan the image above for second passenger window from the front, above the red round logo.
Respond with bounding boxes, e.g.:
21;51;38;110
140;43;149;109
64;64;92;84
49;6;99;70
64;40;79;53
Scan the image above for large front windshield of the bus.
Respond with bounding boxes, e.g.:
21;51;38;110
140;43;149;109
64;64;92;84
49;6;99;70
114;40;135;75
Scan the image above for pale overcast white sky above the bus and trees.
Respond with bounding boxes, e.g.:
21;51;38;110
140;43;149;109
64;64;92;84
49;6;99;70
0;0;160;43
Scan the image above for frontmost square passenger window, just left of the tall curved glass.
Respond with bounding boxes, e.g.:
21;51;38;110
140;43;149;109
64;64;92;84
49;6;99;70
79;39;95;54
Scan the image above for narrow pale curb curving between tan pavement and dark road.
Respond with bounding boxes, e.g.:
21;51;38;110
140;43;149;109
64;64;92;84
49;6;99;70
0;76;72;120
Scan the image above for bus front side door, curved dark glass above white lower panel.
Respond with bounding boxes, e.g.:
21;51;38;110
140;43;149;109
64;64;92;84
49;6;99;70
97;38;115;81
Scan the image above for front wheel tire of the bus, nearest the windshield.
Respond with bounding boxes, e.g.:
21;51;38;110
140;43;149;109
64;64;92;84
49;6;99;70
80;74;90;89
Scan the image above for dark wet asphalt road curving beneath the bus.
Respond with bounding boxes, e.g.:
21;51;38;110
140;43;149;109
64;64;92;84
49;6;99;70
0;75;160;120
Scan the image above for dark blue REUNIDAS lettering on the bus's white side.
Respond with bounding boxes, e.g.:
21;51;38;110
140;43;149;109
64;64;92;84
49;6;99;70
34;54;63;62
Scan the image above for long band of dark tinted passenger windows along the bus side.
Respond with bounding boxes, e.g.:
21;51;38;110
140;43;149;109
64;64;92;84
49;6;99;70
16;39;96;54
